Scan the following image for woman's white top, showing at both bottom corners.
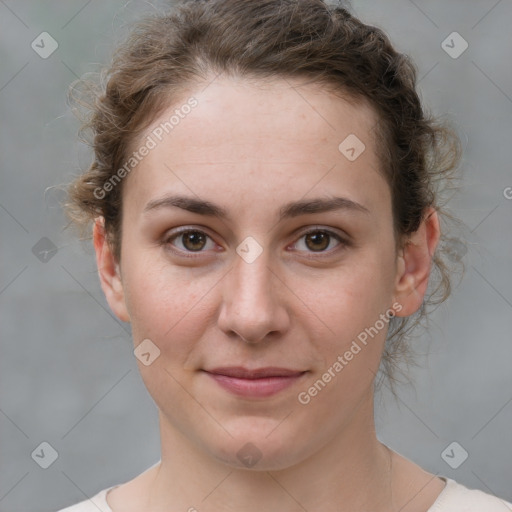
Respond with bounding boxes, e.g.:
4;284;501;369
58;470;512;512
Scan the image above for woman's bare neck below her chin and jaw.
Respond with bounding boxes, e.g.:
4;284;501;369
147;390;392;512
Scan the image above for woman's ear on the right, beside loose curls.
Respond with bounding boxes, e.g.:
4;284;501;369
394;207;441;316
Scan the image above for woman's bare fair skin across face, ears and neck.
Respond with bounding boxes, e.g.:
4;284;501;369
93;77;444;512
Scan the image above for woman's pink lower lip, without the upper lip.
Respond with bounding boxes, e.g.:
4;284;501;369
206;372;306;398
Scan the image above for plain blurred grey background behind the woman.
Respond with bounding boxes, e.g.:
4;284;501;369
0;0;512;512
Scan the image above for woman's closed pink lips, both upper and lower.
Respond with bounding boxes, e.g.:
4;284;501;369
204;366;307;398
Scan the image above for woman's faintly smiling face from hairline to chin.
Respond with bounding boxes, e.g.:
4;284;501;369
93;77;436;469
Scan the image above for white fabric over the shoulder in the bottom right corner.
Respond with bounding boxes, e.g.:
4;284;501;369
428;477;512;512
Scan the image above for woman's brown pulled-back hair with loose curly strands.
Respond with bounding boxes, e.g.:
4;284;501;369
66;0;462;396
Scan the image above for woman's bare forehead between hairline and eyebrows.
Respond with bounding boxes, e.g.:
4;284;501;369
127;77;386;217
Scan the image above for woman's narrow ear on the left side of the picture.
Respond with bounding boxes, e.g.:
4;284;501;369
93;217;130;322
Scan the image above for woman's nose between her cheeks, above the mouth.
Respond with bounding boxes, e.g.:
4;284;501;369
218;251;290;344
